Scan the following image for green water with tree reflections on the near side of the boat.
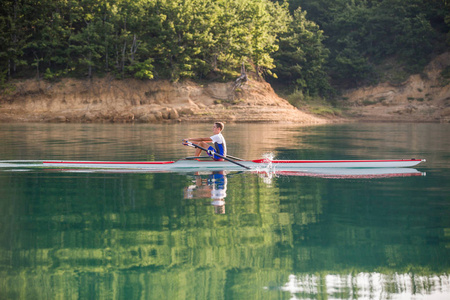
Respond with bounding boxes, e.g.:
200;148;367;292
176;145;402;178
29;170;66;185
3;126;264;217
0;170;450;299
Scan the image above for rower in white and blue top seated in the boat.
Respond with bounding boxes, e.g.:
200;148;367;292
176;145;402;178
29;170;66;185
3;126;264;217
183;122;227;161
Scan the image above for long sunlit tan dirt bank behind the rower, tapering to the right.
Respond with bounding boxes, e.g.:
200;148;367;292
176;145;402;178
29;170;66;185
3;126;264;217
0;78;326;124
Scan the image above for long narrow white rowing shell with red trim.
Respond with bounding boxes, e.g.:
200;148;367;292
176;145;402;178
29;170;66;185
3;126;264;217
0;160;425;179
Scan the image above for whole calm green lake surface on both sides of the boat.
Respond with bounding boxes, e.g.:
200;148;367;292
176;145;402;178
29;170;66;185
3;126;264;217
0;124;450;299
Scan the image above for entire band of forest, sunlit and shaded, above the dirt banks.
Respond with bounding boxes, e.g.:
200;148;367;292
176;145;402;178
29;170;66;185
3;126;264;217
0;0;450;96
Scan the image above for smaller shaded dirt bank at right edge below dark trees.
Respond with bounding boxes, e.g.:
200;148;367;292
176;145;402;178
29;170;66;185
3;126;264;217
341;53;450;123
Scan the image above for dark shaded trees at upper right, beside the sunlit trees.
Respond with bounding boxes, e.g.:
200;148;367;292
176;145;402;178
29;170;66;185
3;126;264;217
289;0;450;87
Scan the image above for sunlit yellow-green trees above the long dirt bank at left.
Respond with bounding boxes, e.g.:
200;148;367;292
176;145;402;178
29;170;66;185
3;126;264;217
0;0;289;80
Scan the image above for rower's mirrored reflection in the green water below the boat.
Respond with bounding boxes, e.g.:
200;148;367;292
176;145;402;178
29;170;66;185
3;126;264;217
184;171;227;214
